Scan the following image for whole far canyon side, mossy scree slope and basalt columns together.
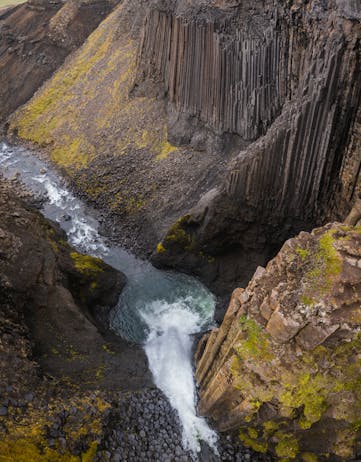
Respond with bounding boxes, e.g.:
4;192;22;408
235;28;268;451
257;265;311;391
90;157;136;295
10;0;361;293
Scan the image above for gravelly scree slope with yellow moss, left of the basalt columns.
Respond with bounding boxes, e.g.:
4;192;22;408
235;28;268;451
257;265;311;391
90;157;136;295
11;2;225;260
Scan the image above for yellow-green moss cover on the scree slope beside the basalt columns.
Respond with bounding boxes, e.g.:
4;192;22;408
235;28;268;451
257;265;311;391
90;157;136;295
10;1;177;214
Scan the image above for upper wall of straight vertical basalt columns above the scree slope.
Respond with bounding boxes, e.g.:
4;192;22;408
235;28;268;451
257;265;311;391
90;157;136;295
138;9;288;140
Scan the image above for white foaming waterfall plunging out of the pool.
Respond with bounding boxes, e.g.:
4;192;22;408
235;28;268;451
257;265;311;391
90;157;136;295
142;299;217;453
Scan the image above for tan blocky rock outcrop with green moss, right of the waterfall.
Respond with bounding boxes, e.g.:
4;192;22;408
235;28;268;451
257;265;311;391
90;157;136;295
196;223;361;461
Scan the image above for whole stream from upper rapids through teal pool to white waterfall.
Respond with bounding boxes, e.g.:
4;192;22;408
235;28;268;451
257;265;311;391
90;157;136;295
0;142;217;453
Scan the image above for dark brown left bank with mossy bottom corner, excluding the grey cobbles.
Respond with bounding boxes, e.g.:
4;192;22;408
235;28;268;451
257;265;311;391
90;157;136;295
0;178;152;462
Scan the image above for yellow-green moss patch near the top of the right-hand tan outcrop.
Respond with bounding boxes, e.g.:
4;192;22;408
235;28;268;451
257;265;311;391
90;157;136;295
296;230;342;305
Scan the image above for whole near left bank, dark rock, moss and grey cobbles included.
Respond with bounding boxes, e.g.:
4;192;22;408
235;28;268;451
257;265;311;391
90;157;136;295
0;162;270;462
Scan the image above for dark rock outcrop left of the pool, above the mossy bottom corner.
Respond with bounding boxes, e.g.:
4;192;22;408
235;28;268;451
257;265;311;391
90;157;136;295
0;179;150;389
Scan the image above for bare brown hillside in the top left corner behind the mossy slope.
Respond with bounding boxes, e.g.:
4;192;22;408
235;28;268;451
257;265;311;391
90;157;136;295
0;0;113;122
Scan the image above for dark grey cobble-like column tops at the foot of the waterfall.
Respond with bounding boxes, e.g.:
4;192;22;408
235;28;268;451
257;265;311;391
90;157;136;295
95;390;271;462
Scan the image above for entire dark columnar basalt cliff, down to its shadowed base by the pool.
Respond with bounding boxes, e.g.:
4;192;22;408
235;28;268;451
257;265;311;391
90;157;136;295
147;1;361;291
